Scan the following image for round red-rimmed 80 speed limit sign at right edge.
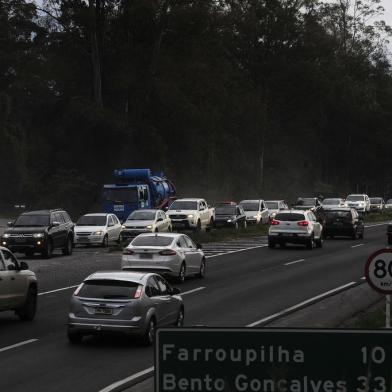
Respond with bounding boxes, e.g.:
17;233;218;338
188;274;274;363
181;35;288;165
365;249;392;294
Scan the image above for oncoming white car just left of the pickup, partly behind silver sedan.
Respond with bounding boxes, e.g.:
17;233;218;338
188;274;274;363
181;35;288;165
121;210;172;241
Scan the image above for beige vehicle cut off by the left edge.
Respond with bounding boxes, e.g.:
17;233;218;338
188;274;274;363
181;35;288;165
0;246;37;321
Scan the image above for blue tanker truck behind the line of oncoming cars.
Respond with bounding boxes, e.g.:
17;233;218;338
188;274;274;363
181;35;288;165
102;169;176;221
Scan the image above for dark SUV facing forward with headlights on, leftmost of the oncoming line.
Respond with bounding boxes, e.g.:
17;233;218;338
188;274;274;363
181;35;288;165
1;209;74;258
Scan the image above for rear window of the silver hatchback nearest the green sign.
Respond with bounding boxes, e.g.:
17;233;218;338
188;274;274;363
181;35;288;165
78;279;139;299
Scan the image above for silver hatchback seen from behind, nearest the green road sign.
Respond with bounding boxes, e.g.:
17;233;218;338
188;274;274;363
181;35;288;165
68;271;184;345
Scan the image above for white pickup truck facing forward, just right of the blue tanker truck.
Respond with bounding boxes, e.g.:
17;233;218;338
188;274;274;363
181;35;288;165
167;199;215;231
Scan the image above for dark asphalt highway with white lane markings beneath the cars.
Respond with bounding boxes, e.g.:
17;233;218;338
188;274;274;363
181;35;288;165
0;225;386;392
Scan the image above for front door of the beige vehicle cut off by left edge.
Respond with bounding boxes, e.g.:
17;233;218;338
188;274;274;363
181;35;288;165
1;249;27;307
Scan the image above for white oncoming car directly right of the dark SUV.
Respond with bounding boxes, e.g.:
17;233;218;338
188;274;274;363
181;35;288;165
74;213;121;247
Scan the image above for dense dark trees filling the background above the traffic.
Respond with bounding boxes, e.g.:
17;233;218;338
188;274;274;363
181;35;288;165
0;0;392;211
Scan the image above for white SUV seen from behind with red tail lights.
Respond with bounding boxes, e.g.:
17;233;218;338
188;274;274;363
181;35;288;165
268;210;323;249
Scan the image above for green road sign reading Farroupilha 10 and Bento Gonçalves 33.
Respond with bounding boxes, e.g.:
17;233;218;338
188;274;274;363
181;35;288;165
155;328;392;392
